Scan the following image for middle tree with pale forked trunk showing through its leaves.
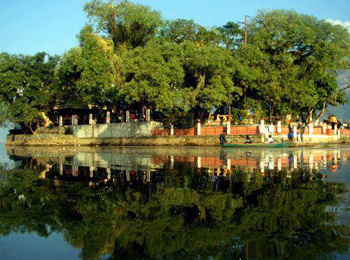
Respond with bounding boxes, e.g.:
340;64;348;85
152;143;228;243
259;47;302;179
183;42;241;121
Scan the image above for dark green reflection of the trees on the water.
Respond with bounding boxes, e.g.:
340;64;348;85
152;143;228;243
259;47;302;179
0;164;350;259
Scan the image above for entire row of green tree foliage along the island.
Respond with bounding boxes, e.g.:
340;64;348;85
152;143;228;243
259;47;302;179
0;3;350;127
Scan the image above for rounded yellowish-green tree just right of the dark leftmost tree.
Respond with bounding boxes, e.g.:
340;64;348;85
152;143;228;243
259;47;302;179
55;26;121;107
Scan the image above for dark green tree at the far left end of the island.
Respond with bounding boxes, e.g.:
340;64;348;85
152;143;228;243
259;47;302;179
0;52;58;133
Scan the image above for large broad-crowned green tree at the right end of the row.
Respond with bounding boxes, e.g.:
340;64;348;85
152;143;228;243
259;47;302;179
237;10;350;120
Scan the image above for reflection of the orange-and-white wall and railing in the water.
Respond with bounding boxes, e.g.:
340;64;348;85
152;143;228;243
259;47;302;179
9;145;350;186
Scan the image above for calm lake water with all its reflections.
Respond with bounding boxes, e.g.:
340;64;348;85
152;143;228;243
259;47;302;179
0;146;350;260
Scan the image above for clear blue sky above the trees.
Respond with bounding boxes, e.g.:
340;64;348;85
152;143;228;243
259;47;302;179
0;0;350;54
